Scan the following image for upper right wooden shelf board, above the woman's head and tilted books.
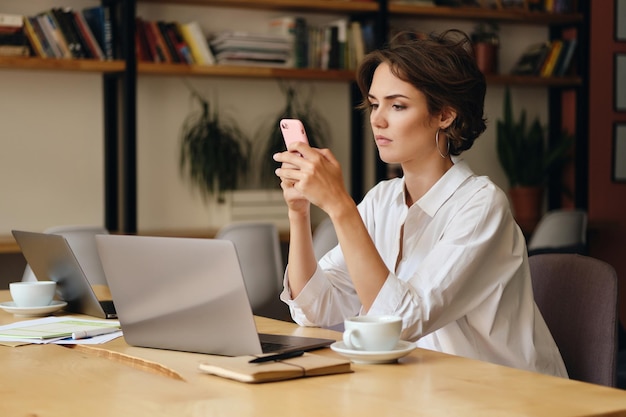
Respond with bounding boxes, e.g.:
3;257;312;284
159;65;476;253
389;2;583;25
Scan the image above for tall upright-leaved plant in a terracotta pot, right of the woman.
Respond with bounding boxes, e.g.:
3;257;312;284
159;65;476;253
496;87;573;233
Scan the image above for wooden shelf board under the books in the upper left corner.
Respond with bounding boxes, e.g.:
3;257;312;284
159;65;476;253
0;56;124;73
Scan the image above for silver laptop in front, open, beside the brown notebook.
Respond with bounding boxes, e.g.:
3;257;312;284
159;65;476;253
96;235;334;356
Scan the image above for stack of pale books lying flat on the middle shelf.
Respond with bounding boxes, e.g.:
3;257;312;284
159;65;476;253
210;31;293;67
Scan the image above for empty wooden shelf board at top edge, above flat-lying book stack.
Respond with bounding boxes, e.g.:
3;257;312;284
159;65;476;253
138;0;379;14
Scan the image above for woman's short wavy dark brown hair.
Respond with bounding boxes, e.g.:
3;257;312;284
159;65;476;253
357;29;487;155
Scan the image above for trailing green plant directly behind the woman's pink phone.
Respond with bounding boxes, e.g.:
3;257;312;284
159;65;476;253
257;84;330;188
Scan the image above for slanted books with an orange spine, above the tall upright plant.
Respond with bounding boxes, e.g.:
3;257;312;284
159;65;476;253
511;39;577;77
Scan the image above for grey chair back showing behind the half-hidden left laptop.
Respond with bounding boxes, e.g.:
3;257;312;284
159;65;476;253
22;225;109;285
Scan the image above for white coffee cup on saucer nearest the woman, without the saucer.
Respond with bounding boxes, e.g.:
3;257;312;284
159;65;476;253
343;316;402;352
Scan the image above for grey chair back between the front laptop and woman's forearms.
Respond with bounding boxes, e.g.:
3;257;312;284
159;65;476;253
215;222;284;315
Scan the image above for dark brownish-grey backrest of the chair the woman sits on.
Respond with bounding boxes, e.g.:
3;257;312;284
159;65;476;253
529;253;618;387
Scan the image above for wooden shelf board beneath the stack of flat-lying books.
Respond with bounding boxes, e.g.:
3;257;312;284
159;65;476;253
137;62;355;81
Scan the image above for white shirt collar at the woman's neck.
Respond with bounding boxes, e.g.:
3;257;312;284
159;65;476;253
396;160;474;217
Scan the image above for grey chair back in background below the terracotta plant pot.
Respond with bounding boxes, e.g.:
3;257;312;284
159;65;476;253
528;209;587;255
